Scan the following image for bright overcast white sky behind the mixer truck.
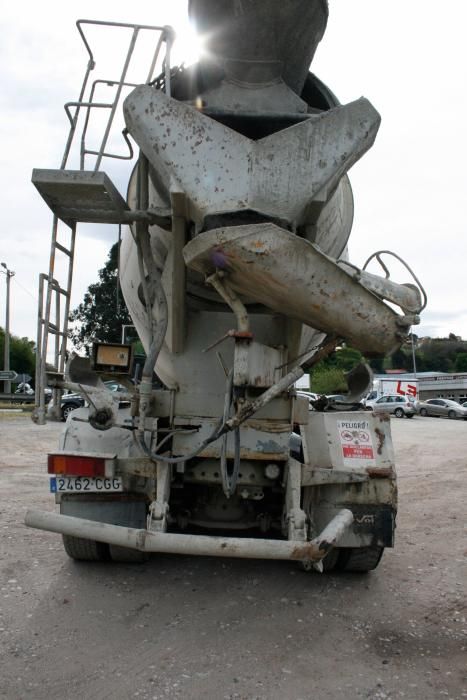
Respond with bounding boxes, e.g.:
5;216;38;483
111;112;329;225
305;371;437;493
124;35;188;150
0;0;467;348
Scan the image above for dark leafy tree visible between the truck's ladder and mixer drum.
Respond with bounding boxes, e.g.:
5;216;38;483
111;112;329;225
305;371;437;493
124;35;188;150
70;243;131;348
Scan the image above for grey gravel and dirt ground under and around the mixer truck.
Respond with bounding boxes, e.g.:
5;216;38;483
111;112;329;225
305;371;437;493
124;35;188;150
0;416;467;700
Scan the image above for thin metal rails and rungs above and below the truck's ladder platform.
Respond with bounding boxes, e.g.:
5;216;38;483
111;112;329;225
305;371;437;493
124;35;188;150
35;19;175;424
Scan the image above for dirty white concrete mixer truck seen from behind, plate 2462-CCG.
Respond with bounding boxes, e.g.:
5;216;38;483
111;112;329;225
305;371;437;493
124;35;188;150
26;0;426;571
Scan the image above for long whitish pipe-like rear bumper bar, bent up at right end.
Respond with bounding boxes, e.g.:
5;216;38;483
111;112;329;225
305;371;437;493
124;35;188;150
25;508;353;562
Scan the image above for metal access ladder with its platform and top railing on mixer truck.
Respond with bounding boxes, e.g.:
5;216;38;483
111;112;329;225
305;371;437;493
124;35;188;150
32;20;175;425
